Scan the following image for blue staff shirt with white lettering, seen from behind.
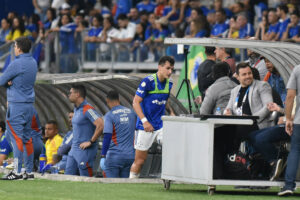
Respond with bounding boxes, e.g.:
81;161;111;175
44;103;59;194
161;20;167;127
103;105;136;158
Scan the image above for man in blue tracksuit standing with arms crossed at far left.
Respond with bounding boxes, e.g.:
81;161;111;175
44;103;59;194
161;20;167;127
0;37;38;180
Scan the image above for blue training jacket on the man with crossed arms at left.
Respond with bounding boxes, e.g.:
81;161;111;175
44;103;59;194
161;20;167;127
0;53;38;103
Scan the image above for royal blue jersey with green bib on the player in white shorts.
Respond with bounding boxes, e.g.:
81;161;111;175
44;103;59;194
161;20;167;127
136;74;173;130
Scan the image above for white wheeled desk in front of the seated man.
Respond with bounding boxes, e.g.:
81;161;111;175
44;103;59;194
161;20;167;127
161;116;298;194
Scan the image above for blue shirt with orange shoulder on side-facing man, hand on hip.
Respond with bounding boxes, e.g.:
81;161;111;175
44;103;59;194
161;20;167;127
72;100;100;149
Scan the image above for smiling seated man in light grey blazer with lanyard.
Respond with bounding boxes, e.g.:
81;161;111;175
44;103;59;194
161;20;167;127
224;63;273;140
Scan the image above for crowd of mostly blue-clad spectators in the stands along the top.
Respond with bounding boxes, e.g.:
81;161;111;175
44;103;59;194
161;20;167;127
0;0;300;72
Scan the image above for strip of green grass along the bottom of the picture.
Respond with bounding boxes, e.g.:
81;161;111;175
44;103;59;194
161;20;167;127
0;179;300;200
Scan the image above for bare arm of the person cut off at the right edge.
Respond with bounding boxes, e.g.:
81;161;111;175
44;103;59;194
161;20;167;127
285;89;296;135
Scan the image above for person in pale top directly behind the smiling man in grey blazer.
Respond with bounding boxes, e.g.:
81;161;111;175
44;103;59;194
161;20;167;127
247;49;268;80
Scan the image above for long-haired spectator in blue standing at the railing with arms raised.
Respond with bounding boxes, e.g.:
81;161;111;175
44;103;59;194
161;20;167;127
51;14;79;73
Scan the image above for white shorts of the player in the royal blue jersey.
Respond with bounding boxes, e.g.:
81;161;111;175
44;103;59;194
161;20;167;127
134;128;163;151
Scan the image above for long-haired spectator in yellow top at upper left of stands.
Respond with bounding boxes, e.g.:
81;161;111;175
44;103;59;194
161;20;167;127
5;17;30;42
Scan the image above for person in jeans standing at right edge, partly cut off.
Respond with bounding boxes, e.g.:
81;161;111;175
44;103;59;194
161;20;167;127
278;65;300;196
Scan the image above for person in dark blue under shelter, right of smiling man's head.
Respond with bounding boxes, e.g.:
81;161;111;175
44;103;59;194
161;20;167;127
264;58;286;103
